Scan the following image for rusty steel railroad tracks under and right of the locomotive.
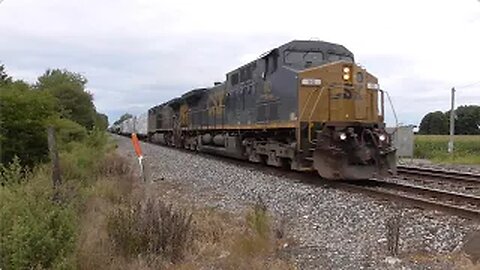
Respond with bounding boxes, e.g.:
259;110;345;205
123;135;480;220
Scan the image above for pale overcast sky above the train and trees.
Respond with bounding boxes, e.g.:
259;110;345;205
0;0;480;124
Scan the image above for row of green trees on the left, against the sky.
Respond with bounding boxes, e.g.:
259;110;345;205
0;65;108;166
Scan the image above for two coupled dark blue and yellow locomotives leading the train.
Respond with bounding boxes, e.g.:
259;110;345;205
148;40;396;179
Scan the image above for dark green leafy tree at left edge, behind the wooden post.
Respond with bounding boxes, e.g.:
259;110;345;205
0;66;96;166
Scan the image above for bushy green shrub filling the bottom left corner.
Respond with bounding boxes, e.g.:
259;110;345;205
0;168;76;269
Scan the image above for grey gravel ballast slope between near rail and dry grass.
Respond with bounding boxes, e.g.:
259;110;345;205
115;136;480;269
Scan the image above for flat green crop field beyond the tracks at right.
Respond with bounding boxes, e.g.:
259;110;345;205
414;135;480;164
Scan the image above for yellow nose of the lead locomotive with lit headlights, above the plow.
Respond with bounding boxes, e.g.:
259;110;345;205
299;62;378;122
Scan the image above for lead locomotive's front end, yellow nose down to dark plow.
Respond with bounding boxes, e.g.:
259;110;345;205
298;61;396;179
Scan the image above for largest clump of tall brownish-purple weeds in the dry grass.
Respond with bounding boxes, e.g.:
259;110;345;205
107;200;193;262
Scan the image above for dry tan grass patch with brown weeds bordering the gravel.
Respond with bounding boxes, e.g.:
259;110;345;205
74;151;293;270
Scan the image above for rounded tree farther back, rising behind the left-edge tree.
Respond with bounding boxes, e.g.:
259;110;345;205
36;69;96;129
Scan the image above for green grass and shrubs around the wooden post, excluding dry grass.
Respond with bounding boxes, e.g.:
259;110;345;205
0;131;112;269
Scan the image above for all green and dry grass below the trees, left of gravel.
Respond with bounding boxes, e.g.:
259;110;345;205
0;130;293;270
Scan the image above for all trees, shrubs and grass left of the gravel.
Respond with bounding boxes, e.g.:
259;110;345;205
0;65;293;270
